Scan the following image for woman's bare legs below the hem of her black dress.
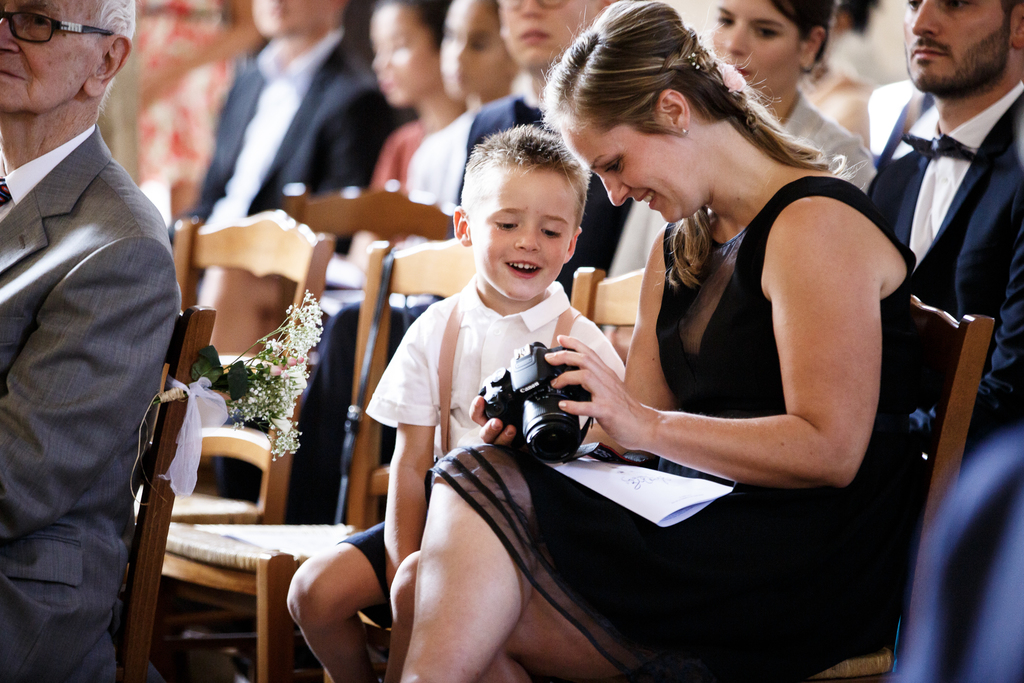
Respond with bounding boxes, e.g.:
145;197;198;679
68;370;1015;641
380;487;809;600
392;482;618;683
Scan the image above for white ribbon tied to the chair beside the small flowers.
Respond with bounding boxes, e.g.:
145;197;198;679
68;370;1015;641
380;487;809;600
160;377;227;496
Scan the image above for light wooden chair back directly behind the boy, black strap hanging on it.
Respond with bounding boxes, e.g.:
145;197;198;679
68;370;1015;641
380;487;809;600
346;240;476;528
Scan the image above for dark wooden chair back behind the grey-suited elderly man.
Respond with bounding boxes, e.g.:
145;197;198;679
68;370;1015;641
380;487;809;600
117;307;216;683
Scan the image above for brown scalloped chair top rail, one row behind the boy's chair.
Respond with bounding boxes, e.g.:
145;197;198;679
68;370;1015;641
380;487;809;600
282;182;452;240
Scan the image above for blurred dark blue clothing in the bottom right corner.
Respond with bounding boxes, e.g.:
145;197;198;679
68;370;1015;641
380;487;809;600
898;423;1024;683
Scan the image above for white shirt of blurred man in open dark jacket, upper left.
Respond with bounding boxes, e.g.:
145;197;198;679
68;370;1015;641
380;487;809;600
207;30;342;223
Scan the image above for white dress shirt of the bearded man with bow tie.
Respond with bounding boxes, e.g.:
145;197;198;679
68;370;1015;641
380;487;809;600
910;83;1024;265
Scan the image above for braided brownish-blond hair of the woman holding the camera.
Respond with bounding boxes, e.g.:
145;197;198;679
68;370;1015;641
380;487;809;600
544;0;828;287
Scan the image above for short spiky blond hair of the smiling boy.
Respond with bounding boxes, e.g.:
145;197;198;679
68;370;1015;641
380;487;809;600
462;125;590;225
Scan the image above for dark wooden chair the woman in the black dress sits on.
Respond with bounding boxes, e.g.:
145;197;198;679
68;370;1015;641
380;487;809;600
811;297;994;682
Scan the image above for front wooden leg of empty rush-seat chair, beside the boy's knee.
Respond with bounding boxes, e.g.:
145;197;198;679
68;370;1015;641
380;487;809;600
256;553;299;683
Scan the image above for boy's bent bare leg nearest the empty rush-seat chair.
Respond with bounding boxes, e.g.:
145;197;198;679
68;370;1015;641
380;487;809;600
288;543;386;683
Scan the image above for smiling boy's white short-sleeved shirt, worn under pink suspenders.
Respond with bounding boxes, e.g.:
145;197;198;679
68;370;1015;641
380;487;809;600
367;278;626;458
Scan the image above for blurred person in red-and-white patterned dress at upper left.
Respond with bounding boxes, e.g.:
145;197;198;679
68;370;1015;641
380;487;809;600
136;0;262;216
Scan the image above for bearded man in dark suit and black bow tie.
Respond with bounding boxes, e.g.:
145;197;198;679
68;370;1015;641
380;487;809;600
870;0;1024;448
